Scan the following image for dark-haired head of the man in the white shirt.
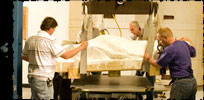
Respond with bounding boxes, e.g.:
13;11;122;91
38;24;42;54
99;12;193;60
40;17;58;35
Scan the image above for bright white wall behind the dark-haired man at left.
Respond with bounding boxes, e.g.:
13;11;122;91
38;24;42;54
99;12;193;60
23;1;69;84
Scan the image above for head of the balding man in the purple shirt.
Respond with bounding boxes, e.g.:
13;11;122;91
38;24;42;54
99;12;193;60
157;28;175;47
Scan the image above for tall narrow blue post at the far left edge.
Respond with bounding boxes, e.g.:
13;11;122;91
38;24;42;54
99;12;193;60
12;1;23;99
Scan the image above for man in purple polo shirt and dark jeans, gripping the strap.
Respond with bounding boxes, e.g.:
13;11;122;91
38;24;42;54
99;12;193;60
144;28;197;100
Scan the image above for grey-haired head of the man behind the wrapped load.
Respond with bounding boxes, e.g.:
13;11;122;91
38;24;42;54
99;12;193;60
129;21;141;37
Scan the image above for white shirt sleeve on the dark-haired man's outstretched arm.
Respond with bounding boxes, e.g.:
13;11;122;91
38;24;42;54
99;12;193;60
51;41;65;57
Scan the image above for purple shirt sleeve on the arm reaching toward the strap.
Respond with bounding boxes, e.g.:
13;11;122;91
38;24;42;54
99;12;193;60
157;51;173;67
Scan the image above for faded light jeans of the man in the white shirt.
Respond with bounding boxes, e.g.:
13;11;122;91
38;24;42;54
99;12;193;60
28;77;53;100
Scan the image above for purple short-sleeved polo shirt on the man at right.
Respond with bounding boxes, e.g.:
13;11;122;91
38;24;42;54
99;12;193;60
157;41;196;78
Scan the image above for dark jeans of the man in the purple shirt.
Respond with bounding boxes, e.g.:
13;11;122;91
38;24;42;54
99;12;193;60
170;78;197;100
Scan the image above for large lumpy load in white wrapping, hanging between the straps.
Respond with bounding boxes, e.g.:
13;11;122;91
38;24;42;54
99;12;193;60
57;35;147;71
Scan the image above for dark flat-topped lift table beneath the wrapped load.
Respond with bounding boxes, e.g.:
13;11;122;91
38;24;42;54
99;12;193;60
71;75;153;99
